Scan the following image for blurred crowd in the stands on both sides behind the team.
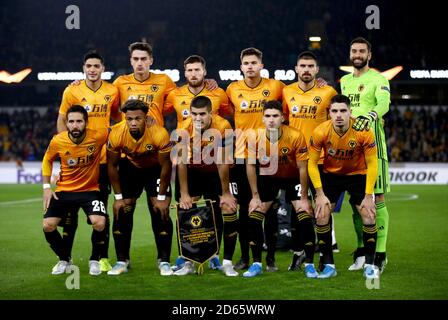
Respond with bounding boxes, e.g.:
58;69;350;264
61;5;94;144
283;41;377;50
0;106;448;162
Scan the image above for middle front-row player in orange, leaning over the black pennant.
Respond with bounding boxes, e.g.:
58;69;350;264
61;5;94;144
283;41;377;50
174;96;238;277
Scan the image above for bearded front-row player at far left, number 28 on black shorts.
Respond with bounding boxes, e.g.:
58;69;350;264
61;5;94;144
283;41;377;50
42;105;108;276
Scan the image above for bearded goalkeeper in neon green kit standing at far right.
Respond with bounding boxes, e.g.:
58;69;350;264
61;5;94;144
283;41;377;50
341;38;390;272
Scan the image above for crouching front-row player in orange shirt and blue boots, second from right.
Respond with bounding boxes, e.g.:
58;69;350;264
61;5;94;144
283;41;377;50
243;100;318;278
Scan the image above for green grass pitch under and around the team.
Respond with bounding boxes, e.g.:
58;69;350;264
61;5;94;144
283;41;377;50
0;185;448;300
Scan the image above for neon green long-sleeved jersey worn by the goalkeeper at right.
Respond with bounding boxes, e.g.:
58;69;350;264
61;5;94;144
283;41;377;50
341;69;390;160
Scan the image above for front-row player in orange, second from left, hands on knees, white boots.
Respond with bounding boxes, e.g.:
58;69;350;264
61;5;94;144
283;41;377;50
107;100;173;276
